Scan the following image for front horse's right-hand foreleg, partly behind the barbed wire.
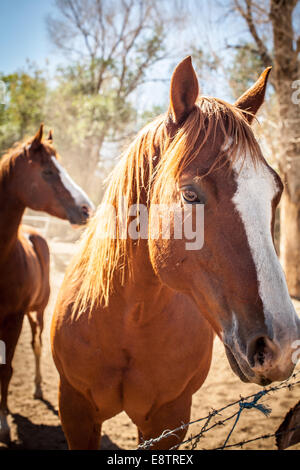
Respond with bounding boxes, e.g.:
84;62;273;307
138;394;192;450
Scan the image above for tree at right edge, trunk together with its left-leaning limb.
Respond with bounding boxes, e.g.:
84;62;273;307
234;0;300;297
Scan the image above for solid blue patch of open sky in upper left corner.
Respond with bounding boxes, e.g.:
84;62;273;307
0;0;57;73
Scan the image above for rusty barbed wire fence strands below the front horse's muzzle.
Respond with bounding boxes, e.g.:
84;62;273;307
138;370;300;450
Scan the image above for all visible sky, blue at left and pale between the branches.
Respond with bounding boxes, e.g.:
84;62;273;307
0;0;288;108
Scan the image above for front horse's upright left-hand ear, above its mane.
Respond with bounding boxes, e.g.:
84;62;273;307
169;56;199;124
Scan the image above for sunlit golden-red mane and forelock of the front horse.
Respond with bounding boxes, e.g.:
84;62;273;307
69;96;263;314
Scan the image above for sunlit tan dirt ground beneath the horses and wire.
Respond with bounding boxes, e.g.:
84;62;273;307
0;241;300;450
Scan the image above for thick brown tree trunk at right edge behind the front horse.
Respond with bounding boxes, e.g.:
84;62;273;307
270;0;300;297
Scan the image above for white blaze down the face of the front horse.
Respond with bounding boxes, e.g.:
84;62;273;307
233;151;297;347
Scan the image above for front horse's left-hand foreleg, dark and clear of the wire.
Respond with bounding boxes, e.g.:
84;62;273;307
59;378;101;450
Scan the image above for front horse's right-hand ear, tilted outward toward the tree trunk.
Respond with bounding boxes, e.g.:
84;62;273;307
235;67;272;124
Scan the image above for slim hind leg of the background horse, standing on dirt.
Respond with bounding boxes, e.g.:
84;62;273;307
27;310;44;399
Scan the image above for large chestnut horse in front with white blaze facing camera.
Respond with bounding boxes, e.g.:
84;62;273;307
51;58;299;449
